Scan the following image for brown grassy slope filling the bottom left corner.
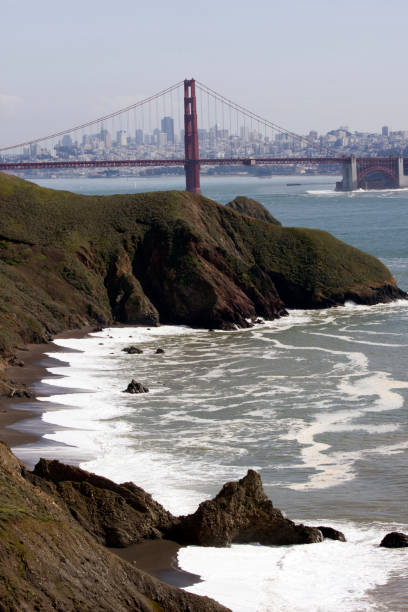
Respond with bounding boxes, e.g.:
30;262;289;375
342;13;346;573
0;442;227;612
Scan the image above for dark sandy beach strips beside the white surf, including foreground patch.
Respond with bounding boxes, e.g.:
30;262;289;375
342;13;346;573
0;326;201;588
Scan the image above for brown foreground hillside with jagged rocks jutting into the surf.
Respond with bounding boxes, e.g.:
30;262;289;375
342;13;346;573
0;443;358;612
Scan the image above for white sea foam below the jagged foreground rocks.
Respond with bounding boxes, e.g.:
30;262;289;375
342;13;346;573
178;519;408;612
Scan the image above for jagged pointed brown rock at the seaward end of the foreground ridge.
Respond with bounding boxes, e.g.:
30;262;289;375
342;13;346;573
169;470;323;546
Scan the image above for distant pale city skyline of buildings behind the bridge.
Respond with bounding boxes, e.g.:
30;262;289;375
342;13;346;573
7;115;408;167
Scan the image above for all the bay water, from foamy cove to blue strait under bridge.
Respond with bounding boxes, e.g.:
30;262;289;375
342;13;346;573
15;176;408;612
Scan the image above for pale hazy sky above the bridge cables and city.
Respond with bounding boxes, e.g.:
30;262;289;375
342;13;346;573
0;0;408;146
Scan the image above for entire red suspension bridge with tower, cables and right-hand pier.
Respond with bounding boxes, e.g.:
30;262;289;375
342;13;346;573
0;79;408;193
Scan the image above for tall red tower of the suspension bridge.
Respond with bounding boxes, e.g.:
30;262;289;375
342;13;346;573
184;79;201;193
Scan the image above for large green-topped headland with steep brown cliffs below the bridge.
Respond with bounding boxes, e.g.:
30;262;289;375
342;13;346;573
0;173;405;388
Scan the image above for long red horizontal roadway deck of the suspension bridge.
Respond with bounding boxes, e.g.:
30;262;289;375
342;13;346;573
0;157;348;171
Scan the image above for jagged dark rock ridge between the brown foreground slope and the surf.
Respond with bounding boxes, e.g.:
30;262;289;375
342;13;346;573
27;459;323;547
